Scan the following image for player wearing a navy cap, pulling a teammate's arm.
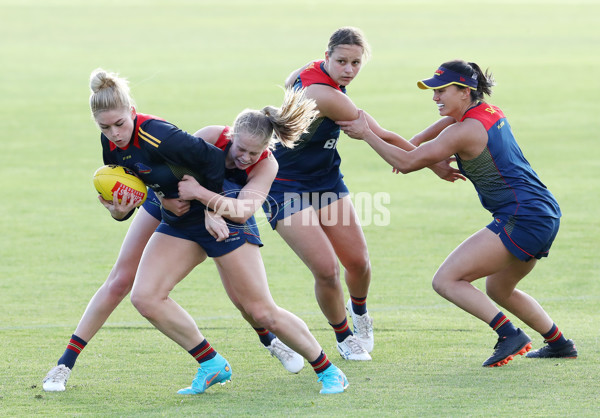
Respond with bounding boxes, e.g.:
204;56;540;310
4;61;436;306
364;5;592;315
338;60;577;367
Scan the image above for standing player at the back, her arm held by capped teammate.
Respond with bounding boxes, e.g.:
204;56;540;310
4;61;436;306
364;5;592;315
265;27;460;360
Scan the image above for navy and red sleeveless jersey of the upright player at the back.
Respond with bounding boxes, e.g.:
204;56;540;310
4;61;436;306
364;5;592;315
273;60;346;186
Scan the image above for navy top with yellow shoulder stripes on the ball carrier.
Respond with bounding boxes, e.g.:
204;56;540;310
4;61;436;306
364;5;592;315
101;113;225;225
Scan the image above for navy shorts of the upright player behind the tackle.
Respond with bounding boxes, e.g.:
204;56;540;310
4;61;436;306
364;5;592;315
263;175;349;229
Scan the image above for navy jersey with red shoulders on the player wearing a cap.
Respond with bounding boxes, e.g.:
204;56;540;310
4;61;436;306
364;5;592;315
456;103;561;218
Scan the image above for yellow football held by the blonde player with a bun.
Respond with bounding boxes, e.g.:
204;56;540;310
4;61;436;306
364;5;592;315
94;165;148;206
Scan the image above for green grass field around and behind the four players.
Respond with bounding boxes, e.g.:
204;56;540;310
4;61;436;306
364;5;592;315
0;0;600;417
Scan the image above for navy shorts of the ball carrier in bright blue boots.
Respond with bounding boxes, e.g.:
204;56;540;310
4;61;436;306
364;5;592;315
156;216;263;257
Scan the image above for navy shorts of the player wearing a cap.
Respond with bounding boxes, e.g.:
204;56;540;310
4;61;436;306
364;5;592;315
487;216;560;261
